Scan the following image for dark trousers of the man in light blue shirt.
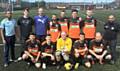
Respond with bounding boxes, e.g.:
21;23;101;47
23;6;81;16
4;36;15;63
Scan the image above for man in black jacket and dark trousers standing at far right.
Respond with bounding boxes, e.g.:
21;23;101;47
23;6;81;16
103;15;120;64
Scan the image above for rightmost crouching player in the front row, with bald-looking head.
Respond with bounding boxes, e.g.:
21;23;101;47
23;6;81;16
88;32;112;64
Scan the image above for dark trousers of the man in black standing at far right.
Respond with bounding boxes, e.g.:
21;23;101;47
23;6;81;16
104;40;117;61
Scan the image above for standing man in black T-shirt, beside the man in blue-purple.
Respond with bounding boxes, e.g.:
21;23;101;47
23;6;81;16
17;8;34;60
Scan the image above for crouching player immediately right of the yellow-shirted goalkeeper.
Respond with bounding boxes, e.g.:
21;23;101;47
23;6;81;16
71;33;91;69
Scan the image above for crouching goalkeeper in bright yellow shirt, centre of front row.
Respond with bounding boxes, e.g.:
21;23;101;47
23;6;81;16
55;32;72;69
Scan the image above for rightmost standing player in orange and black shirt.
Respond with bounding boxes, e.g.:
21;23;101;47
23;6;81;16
81;10;96;48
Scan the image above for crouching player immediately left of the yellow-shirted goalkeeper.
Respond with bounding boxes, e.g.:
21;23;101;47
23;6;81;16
41;34;55;69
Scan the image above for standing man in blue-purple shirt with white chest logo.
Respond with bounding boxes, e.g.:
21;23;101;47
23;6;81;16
34;8;49;42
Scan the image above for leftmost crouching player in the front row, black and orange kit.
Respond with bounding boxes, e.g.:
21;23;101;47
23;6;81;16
22;33;41;68
